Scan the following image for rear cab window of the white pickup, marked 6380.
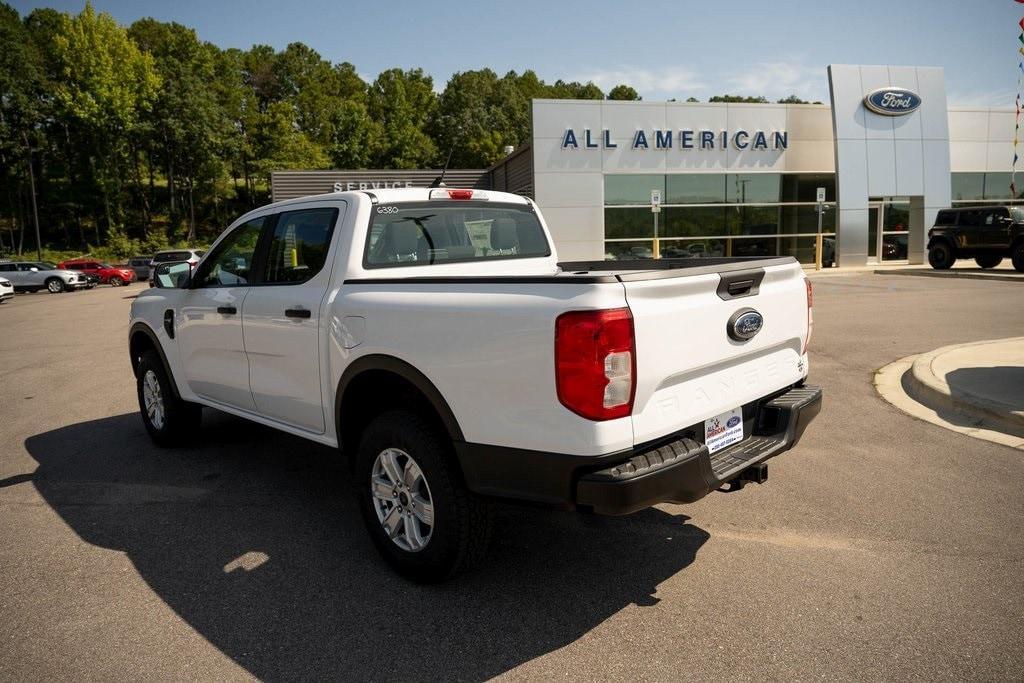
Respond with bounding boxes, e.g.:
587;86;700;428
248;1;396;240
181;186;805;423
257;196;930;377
364;202;551;268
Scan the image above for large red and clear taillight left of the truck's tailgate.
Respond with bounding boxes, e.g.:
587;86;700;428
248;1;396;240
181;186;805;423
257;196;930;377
555;308;636;420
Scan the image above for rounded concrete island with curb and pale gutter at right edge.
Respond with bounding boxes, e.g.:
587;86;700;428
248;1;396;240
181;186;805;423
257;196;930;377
874;337;1024;450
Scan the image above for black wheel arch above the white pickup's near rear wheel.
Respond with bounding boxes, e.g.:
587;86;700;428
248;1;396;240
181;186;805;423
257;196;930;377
334;354;465;452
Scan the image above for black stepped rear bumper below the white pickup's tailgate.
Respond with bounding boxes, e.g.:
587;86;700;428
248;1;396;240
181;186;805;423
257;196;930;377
575;386;821;515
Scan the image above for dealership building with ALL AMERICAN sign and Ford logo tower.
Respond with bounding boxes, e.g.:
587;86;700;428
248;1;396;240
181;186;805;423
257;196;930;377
271;65;1024;266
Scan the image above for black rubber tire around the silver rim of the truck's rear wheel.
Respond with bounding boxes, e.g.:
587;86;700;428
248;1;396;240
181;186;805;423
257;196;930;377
354;411;492;583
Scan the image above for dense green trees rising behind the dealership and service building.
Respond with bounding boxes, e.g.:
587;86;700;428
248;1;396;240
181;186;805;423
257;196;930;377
0;0;640;253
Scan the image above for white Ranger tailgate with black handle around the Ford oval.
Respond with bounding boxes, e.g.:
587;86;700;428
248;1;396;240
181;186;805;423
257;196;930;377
621;261;808;444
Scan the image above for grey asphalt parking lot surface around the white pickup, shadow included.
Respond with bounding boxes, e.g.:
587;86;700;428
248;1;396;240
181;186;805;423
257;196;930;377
0;272;1024;680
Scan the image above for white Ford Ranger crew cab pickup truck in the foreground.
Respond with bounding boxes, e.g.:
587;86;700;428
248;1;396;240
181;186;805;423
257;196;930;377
129;187;821;581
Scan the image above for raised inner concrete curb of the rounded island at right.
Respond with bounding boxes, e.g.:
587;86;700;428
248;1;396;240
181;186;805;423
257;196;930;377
905;338;1024;436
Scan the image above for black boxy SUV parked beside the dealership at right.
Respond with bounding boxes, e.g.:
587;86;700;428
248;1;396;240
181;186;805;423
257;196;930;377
928;206;1024;272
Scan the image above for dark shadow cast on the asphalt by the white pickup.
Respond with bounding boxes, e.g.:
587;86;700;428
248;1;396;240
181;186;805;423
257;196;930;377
26;411;709;680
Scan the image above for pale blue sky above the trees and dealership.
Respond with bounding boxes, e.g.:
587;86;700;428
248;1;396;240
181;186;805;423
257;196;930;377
8;0;1024;105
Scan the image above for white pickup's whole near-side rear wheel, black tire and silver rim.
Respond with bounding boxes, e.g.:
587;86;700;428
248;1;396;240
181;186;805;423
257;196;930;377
355;412;490;583
